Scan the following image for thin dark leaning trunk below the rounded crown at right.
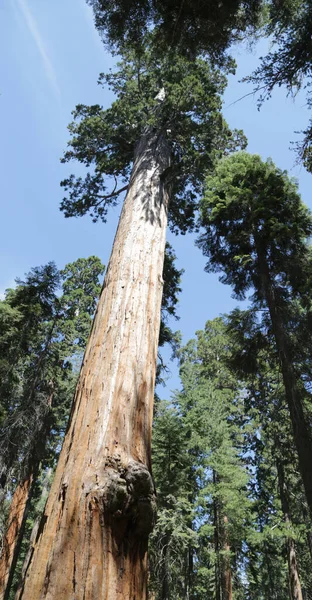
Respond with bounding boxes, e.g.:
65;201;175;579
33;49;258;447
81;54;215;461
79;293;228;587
254;233;312;514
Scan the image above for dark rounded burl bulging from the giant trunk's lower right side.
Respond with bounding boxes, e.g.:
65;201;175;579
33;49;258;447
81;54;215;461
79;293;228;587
103;461;156;538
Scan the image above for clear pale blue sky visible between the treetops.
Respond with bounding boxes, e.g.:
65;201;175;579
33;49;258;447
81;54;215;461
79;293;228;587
0;0;312;387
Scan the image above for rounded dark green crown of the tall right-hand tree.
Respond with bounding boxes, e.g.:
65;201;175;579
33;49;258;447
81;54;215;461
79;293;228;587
198;152;312;304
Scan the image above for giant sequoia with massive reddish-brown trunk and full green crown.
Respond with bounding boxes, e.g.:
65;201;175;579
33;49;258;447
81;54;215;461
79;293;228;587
15;36;245;600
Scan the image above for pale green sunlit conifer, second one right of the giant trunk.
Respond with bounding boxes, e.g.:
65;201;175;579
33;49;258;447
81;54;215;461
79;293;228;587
177;318;250;600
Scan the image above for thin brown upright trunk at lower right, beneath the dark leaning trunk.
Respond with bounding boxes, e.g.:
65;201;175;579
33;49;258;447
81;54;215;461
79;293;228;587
277;460;303;600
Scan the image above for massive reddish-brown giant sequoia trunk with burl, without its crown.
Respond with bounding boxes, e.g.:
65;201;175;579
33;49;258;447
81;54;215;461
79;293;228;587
16;130;170;600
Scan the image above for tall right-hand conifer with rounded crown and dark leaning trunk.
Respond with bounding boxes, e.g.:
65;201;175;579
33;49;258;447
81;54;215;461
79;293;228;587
199;153;312;510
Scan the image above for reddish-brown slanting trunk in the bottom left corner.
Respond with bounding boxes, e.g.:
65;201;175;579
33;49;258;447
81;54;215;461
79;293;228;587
0;474;33;600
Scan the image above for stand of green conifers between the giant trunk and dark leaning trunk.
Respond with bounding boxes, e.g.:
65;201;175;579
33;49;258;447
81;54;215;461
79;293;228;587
150;309;312;600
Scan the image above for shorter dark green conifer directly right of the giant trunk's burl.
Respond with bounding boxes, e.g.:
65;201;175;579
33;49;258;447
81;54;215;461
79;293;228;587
149;402;196;599
